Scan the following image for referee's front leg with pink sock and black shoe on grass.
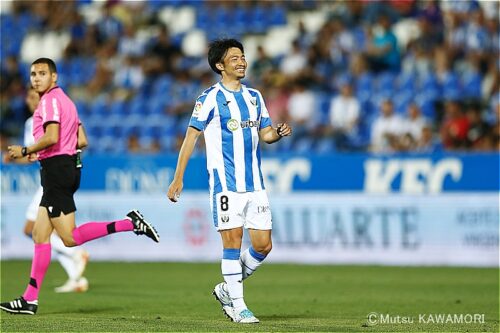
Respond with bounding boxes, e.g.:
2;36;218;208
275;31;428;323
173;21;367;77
0;207;53;315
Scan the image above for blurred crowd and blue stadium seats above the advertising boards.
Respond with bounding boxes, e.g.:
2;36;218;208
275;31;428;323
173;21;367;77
0;0;500;153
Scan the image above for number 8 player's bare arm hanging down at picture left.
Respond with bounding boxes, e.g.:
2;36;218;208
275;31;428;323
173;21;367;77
167;127;201;202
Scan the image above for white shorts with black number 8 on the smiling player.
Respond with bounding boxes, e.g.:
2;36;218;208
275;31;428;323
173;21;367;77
211;190;273;230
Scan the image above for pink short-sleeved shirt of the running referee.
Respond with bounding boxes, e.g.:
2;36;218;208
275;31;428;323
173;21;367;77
33;87;80;160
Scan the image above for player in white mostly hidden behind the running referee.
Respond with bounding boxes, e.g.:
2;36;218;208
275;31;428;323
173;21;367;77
4;87;89;293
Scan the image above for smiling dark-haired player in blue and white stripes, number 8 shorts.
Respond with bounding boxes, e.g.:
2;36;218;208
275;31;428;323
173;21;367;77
168;39;292;323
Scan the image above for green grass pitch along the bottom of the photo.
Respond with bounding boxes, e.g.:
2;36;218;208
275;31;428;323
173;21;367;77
1;261;499;332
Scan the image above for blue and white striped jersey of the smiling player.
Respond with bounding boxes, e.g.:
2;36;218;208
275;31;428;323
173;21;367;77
189;82;271;193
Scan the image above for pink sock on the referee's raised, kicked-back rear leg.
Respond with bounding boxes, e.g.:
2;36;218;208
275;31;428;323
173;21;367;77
73;219;134;245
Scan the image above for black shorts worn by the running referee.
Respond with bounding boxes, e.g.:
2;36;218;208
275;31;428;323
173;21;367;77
40;155;81;217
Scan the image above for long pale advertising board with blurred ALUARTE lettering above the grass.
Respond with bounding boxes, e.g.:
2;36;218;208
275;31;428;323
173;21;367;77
1;192;499;267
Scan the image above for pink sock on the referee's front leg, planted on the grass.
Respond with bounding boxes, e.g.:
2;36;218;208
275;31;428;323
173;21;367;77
23;243;52;301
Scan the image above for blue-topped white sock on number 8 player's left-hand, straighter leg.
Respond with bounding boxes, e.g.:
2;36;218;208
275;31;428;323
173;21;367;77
221;249;247;313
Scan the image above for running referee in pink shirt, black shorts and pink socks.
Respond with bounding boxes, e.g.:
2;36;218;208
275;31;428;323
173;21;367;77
0;58;159;315
